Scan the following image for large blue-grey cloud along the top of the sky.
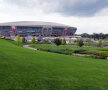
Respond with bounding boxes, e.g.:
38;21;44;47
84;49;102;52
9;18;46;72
5;0;108;16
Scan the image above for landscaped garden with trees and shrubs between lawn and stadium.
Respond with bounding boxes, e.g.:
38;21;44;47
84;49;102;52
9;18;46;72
4;35;108;59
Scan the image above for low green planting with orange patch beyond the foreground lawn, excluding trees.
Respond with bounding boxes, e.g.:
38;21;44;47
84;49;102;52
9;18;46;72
30;44;108;59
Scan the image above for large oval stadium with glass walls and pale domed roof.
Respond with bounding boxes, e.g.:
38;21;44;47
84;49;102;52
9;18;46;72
0;21;77;37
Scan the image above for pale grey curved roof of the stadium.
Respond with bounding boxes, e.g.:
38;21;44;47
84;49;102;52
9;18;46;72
0;21;75;28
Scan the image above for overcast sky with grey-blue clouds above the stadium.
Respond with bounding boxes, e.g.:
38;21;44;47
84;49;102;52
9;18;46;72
0;0;108;34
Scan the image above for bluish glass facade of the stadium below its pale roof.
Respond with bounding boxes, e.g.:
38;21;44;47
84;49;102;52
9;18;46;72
0;26;76;37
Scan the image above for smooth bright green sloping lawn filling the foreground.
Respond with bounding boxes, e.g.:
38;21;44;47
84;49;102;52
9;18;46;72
0;39;108;90
